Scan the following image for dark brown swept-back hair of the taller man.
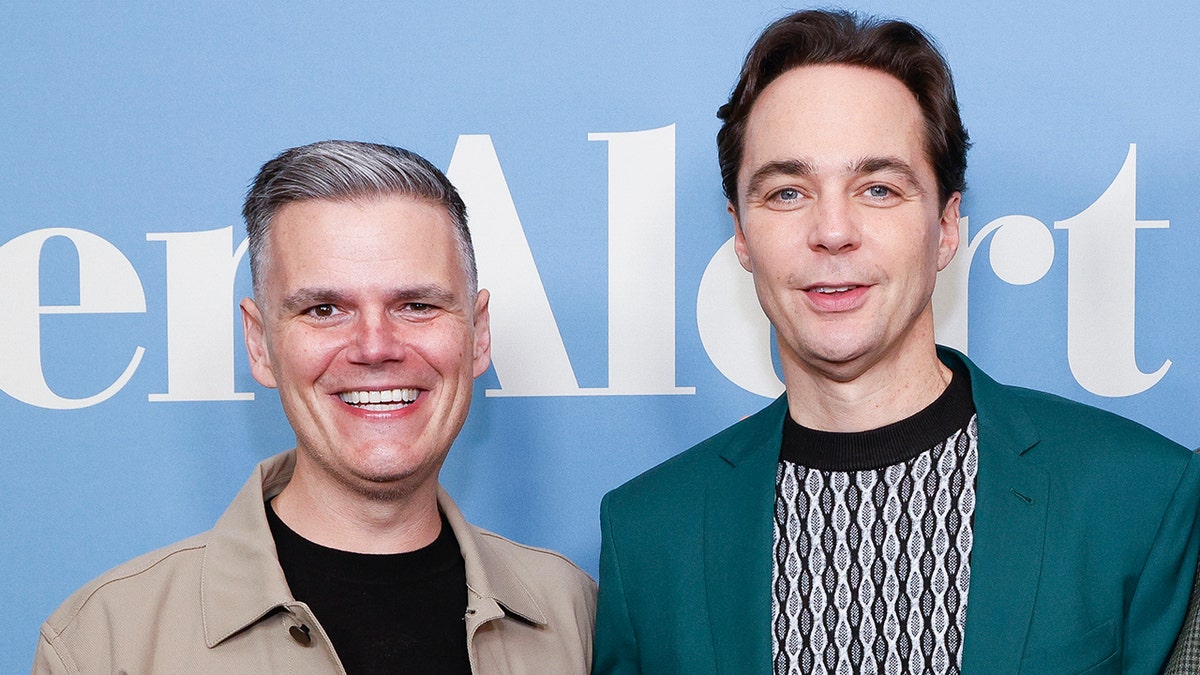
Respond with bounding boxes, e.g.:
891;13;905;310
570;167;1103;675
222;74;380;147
716;10;971;207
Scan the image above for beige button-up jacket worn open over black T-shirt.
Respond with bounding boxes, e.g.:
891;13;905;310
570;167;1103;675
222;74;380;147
34;452;596;675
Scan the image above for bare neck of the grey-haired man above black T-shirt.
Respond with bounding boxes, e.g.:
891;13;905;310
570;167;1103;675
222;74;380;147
270;455;442;554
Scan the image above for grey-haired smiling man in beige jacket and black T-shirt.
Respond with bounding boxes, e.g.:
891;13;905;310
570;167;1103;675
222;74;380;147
34;141;595;673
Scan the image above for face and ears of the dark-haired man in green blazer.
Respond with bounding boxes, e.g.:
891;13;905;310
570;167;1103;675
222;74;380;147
730;65;960;381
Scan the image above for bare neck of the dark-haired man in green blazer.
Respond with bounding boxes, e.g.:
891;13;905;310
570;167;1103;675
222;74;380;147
784;345;953;432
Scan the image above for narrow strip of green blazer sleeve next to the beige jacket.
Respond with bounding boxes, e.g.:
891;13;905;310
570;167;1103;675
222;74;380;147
592;494;641;675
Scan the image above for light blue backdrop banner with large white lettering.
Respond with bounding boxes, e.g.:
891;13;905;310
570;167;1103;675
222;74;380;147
0;0;1200;673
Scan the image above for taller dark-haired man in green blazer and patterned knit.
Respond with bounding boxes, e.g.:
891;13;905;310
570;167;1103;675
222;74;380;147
594;11;1200;675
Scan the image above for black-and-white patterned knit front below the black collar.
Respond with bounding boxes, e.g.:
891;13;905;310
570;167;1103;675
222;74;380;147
772;417;978;675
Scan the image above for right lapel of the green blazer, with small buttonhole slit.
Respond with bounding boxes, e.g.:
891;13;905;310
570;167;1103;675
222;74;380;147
941;350;1050;674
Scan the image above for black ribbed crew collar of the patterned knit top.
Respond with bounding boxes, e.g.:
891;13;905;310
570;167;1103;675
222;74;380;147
779;362;974;471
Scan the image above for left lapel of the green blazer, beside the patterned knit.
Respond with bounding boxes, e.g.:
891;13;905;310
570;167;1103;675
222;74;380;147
704;398;787;673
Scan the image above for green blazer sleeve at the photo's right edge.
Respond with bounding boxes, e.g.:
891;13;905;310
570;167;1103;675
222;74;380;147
1123;453;1200;673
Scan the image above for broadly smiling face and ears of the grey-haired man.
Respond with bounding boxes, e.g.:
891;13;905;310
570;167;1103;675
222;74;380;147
242;196;490;497
